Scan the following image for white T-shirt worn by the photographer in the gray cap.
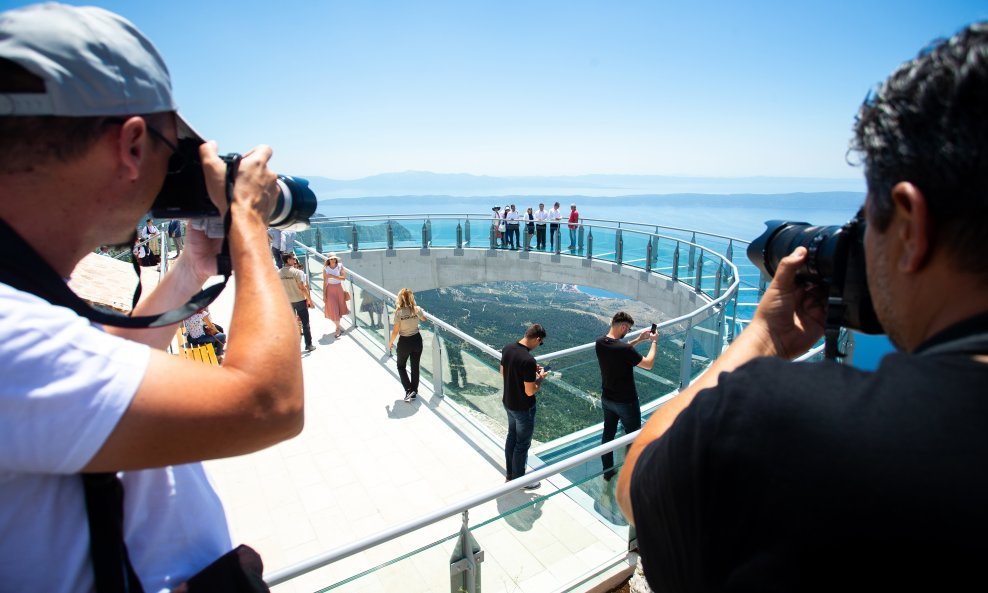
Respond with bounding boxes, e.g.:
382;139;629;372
0;284;232;593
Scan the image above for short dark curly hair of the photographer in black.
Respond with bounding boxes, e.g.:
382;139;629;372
851;22;988;270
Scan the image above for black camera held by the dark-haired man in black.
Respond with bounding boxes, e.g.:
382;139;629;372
748;213;885;334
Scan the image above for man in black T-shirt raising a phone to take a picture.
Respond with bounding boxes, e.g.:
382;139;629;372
595;311;658;481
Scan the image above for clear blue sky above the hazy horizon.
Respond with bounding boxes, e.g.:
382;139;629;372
0;0;988;179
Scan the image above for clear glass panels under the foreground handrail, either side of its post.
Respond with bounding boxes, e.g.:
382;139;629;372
298;460;629;593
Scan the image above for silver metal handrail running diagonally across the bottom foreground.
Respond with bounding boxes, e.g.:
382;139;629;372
264;430;640;587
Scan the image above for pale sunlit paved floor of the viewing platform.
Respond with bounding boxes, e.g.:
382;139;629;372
73;256;627;593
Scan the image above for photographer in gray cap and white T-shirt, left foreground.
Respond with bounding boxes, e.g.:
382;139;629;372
0;4;303;593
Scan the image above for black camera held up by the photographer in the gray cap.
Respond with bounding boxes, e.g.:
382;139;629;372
151;137;316;236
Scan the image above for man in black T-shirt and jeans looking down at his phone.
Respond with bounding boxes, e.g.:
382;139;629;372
501;323;546;490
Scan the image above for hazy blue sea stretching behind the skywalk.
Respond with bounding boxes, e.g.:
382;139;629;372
318;191;893;370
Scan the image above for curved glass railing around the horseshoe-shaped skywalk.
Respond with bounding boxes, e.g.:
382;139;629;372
297;214;740;443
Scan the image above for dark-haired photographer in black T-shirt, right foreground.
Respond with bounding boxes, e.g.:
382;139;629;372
618;23;988;591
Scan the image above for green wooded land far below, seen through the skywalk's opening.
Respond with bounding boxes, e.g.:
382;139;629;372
416;282;698;442
